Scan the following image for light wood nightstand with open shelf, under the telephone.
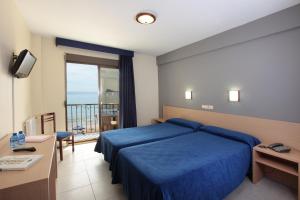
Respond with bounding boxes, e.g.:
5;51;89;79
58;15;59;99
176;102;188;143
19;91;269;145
252;146;300;200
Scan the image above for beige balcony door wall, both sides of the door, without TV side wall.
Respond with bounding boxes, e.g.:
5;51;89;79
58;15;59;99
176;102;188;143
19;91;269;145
32;35;158;130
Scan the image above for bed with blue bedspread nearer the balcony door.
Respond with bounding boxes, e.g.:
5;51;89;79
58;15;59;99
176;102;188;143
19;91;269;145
95;118;202;170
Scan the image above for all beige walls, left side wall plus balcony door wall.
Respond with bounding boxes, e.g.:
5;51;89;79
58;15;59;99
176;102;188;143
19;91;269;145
0;0;158;138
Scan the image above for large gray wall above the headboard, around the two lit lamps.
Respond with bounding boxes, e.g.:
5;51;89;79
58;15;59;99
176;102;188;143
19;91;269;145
158;17;300;123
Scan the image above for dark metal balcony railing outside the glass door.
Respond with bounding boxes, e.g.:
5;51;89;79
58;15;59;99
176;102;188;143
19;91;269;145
66;104;119;133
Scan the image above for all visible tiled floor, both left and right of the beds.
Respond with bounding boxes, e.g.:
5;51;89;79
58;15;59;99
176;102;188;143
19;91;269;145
57;143;297;200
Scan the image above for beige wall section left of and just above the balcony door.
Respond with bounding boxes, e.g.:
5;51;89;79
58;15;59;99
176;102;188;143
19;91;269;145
31;35;118;130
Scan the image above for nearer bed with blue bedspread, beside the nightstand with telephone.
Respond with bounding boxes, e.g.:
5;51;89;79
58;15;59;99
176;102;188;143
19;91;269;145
112;126;259;200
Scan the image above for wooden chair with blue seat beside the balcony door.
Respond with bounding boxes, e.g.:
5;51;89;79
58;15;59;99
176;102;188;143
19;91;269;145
41;112;75;161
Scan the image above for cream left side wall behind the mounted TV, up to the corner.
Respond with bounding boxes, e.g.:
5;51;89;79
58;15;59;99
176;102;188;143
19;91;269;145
0;0;31;138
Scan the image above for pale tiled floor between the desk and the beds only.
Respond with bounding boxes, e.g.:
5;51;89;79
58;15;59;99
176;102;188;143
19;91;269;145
56;143;126;200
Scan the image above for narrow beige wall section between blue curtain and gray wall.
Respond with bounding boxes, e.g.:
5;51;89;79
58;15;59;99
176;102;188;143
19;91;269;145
133;53;158;125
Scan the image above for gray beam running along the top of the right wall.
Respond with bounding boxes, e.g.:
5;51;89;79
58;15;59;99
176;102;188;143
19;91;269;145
157;5;300;65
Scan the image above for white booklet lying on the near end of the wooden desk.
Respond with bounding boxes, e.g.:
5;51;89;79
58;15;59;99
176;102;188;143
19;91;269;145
0;155;43;171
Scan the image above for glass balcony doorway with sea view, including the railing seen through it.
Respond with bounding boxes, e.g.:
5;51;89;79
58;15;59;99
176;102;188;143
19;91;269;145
66;63;119;138
